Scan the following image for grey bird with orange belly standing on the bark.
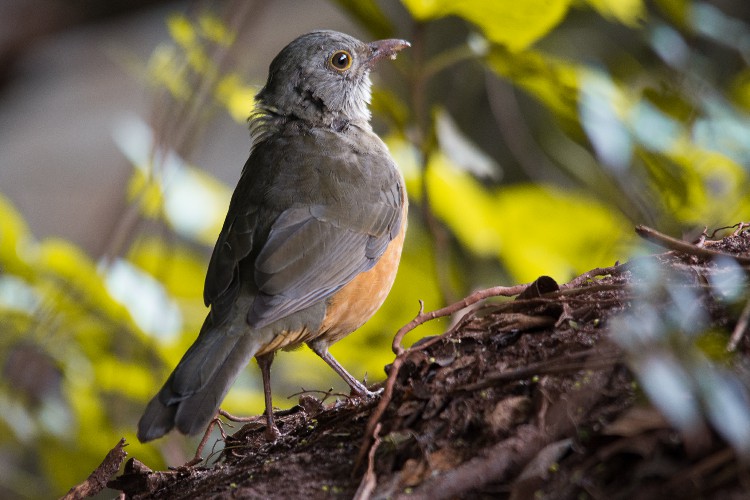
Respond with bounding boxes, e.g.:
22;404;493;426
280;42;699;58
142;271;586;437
137;30;410;442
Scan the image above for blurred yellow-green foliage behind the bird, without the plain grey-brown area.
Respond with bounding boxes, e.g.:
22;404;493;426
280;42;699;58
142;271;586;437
0;0;750;498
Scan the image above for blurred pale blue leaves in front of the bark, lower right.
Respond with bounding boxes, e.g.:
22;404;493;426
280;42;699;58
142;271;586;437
610;257;750;459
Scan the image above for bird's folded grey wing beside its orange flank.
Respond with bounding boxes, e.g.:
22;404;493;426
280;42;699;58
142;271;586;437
248;188;402;326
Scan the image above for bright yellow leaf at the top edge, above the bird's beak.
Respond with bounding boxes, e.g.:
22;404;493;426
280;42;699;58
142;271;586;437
402;0;571;51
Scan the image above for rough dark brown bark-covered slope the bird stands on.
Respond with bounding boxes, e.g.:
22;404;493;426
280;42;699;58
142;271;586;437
104;231;750;500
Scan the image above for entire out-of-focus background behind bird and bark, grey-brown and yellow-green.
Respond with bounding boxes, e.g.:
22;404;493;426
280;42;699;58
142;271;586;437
0;0;750;498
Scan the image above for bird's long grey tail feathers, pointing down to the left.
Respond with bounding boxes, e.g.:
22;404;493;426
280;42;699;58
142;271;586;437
138;315;262;443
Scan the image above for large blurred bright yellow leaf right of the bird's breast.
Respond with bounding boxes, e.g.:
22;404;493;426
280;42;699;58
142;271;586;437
388;134;633;281
